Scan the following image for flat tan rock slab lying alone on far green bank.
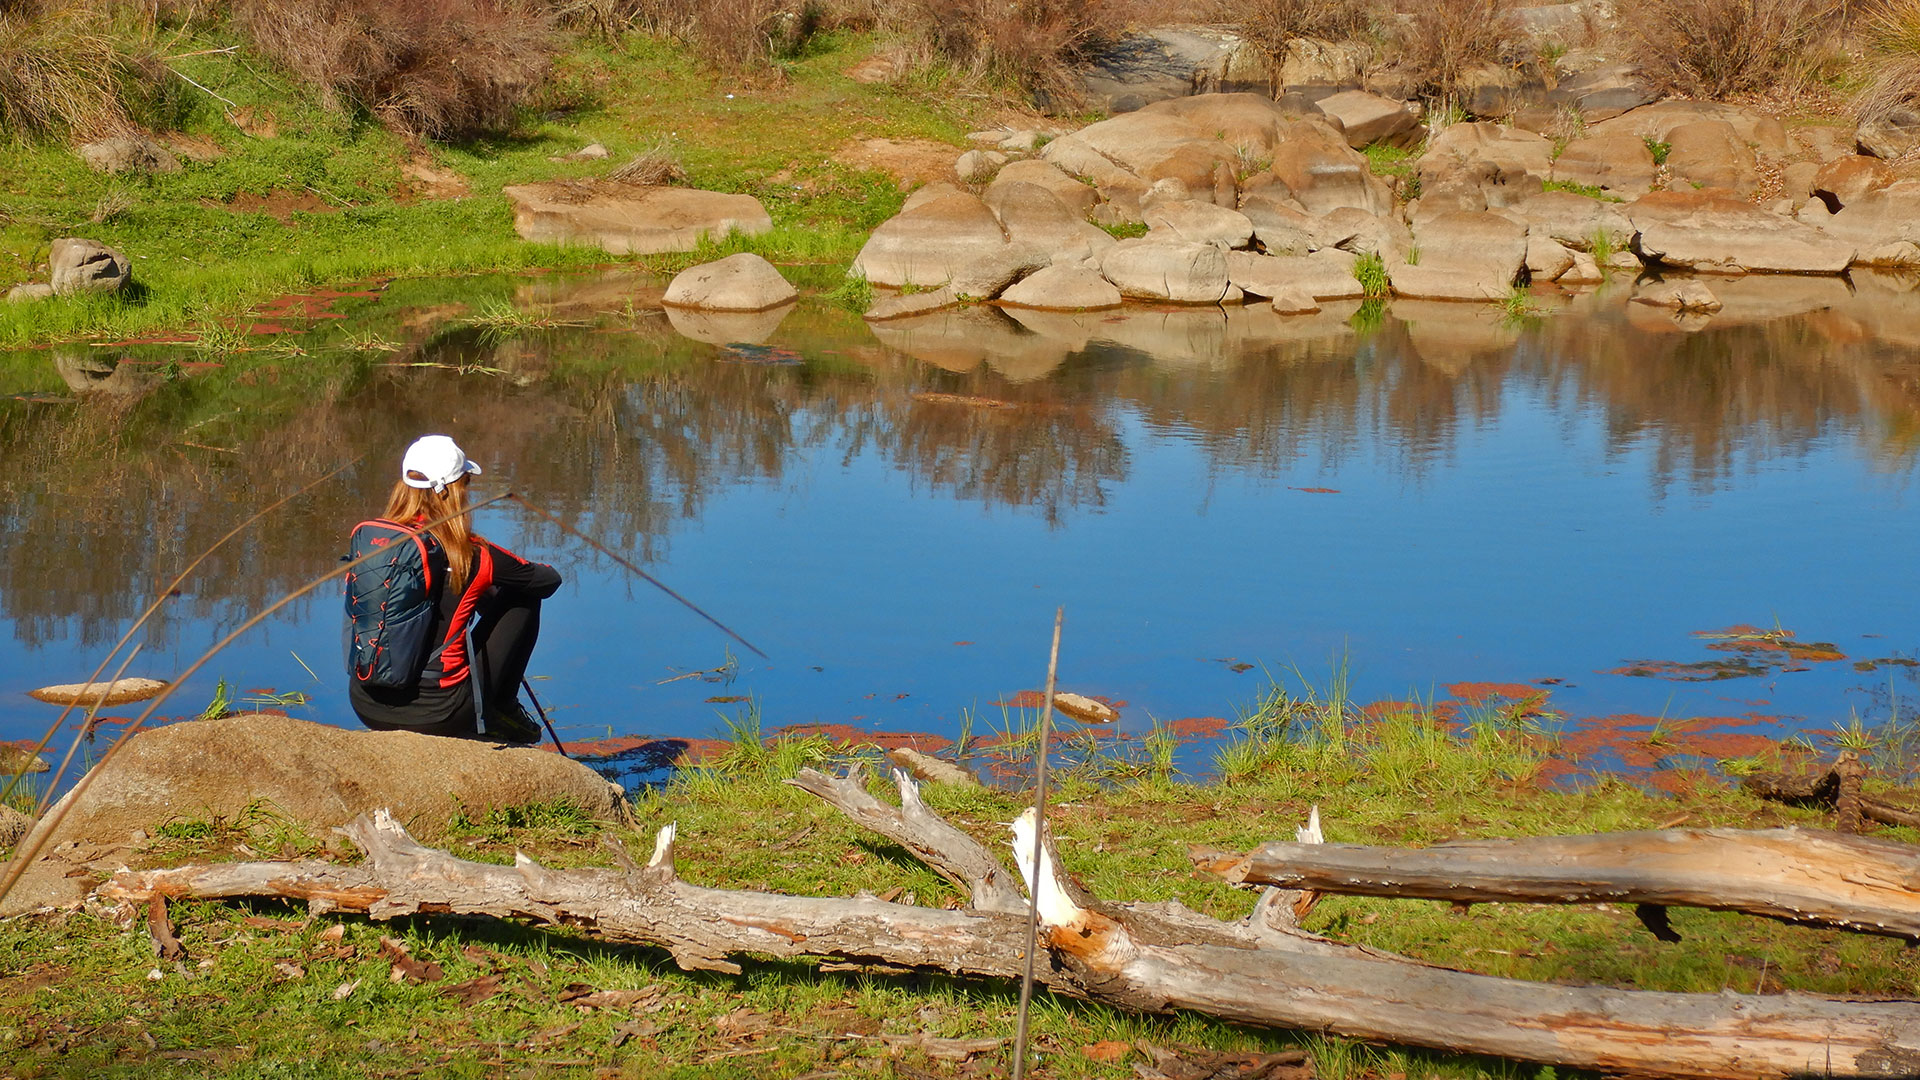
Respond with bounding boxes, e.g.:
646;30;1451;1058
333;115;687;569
503;181;774;256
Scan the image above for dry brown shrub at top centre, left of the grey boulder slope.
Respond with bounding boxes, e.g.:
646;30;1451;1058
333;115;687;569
891;0;1150;100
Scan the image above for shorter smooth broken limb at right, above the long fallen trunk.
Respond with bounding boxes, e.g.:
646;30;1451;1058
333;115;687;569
1194;828;1920;938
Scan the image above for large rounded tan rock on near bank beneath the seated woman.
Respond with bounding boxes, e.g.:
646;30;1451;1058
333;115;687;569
0;715;626;915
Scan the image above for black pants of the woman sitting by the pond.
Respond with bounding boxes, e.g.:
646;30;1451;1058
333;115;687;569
349;598;540;738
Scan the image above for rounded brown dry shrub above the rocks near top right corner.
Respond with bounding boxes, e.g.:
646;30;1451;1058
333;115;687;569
1619;0;1843;98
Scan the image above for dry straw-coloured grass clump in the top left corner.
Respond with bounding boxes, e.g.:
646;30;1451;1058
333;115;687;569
0;0;131;138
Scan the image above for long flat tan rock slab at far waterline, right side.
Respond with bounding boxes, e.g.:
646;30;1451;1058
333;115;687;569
1626;190;1855;273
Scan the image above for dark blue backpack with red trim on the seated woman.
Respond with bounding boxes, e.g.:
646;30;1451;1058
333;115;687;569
346;519;447;688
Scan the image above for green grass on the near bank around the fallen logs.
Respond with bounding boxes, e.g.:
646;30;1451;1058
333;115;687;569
0;691;1920;1080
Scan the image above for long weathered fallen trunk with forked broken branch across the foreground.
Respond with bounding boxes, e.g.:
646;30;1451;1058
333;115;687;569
100;773;1920;1080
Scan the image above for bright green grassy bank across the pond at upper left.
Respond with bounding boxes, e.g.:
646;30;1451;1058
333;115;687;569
0;31;993;346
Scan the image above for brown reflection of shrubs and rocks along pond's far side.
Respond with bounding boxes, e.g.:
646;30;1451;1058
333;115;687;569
0;263;1920;749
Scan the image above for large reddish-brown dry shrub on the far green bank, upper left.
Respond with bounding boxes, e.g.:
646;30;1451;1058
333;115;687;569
232;0;555;138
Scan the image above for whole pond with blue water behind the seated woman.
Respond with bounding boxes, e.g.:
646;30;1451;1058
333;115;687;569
0;271;1920;791
